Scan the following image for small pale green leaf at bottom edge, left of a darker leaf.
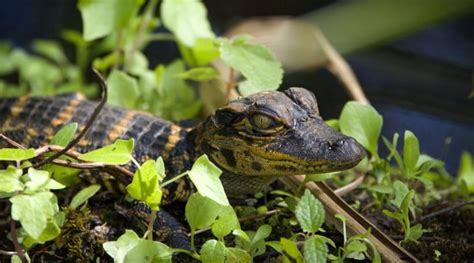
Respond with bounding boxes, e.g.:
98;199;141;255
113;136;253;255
103;229;140;263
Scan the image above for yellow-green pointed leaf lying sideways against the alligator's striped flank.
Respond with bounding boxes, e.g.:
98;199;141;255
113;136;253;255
78;138;134;165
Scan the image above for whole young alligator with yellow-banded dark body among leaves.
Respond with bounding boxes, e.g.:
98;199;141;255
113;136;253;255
0;88;365;256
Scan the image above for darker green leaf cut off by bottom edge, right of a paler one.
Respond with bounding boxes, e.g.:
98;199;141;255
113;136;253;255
124;239;173;263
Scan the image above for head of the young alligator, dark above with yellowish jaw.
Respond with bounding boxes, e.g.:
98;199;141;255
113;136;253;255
196;88;365;195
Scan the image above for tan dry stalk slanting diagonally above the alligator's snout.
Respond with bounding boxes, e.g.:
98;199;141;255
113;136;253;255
314;27;370;104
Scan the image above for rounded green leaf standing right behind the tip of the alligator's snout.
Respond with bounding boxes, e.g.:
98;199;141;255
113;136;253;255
339;101;383;156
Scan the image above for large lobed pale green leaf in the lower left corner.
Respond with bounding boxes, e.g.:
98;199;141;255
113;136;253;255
10;192;59;239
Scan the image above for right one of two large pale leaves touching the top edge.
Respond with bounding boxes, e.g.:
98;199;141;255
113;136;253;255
161;0;214;47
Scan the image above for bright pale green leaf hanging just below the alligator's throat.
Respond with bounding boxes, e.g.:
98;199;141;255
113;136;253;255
188;155;229;206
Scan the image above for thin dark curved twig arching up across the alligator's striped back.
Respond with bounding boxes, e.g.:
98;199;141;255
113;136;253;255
33;69;107;168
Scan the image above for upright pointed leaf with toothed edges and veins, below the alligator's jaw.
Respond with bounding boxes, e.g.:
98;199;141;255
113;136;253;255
295;189;325;233
